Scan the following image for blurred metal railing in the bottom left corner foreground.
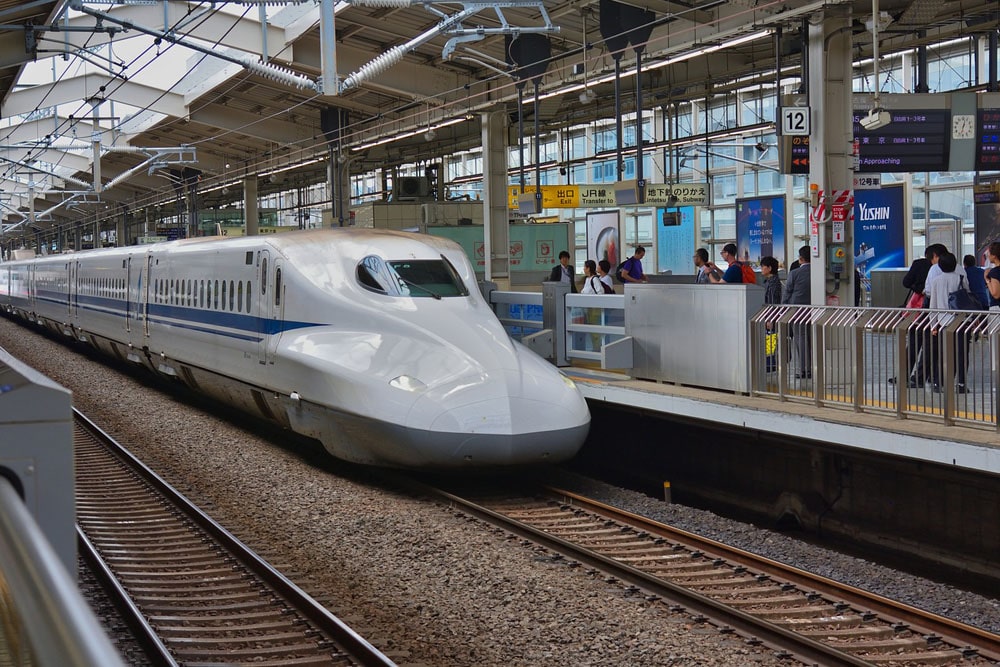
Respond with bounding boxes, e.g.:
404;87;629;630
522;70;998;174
0;475;124;667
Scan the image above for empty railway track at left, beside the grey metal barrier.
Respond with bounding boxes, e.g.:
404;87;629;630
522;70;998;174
73;413;394;667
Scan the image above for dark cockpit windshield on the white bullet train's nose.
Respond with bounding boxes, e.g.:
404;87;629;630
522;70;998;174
358;255;469;299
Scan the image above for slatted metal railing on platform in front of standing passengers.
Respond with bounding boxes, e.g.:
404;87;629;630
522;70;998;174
750;305;1000;430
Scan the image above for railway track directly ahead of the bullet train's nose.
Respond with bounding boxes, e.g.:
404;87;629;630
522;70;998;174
424;480;1000;667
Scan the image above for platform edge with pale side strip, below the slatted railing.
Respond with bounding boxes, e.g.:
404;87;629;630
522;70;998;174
562;366;1000;475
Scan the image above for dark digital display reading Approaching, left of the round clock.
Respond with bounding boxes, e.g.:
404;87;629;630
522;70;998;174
854;109;951;173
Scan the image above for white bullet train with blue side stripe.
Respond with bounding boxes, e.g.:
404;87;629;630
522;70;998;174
0;229;590;468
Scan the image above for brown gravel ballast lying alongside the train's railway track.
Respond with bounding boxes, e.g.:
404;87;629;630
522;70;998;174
0;318;1000;666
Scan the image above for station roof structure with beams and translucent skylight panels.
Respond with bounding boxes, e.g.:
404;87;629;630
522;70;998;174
0;0;1000;238
